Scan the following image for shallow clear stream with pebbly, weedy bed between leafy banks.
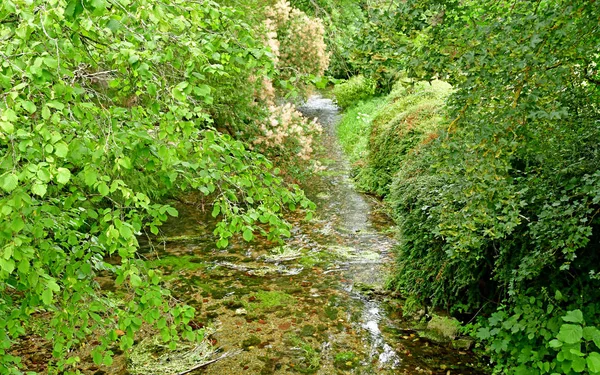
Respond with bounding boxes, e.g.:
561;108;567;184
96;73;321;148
148;96;486;375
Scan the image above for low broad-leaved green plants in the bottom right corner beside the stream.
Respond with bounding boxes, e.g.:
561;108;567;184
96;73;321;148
476;304;600;375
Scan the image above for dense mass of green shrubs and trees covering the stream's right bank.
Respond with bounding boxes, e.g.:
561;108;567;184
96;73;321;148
328;0;600;374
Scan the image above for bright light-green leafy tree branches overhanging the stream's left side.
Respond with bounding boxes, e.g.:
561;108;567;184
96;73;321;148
0;0;311;374
